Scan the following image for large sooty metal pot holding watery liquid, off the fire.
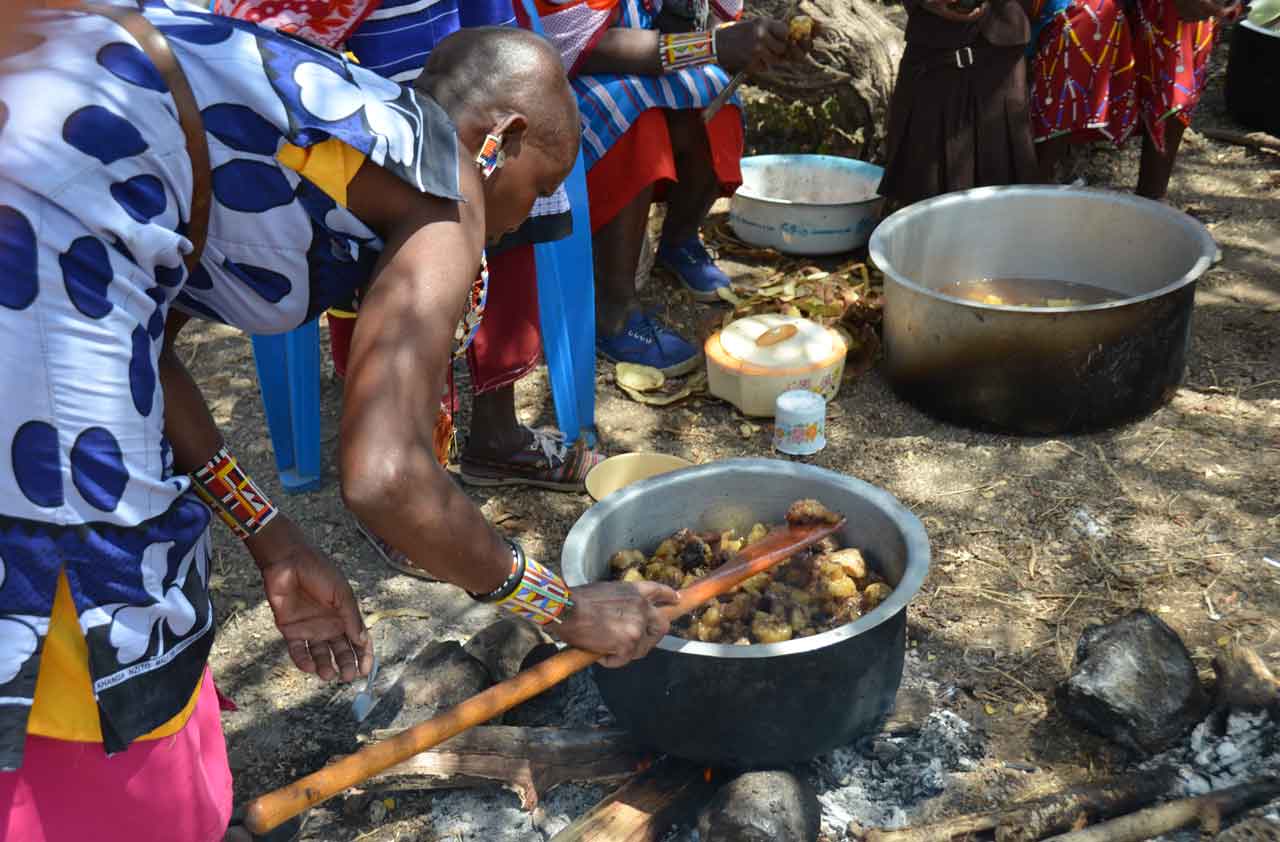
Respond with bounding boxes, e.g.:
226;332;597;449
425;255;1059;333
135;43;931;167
870;187;1217;434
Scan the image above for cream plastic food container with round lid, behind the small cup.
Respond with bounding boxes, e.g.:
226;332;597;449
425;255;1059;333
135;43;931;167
705;314;847;417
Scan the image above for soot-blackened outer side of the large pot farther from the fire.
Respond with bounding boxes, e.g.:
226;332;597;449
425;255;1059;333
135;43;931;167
884;284;1196;435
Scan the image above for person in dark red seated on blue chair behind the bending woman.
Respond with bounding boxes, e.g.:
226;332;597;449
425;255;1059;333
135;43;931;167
214;0;604;499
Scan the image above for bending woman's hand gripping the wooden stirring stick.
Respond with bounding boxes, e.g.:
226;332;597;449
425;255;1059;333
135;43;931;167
548;582;678;667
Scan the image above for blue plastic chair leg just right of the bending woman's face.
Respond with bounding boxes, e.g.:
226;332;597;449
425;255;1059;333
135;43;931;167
521;0;595;445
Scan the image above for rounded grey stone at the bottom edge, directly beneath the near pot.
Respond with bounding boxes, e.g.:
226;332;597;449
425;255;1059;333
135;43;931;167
698;772;820;842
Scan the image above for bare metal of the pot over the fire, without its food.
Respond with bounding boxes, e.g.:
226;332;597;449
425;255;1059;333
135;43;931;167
561;459;929;769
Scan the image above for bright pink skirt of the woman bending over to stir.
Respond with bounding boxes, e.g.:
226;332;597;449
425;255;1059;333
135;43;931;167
0;671;232;842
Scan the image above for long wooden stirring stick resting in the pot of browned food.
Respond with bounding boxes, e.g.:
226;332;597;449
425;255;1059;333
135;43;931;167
244;521;845;834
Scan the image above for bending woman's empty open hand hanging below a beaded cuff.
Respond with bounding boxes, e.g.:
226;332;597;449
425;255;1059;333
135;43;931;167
246;514;374;681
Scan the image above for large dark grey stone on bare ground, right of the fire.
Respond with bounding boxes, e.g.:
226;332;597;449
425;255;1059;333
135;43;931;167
1059;612;1208;755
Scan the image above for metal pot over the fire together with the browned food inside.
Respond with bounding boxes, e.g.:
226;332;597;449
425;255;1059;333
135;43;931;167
562;459;929;768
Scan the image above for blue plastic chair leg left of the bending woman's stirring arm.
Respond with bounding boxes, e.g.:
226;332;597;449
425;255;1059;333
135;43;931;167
253;321;320;494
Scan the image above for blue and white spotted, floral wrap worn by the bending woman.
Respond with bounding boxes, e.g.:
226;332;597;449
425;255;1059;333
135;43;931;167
0;0;460;769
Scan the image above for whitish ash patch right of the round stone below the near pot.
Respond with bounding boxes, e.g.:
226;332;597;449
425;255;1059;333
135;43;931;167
663;710;983;842
